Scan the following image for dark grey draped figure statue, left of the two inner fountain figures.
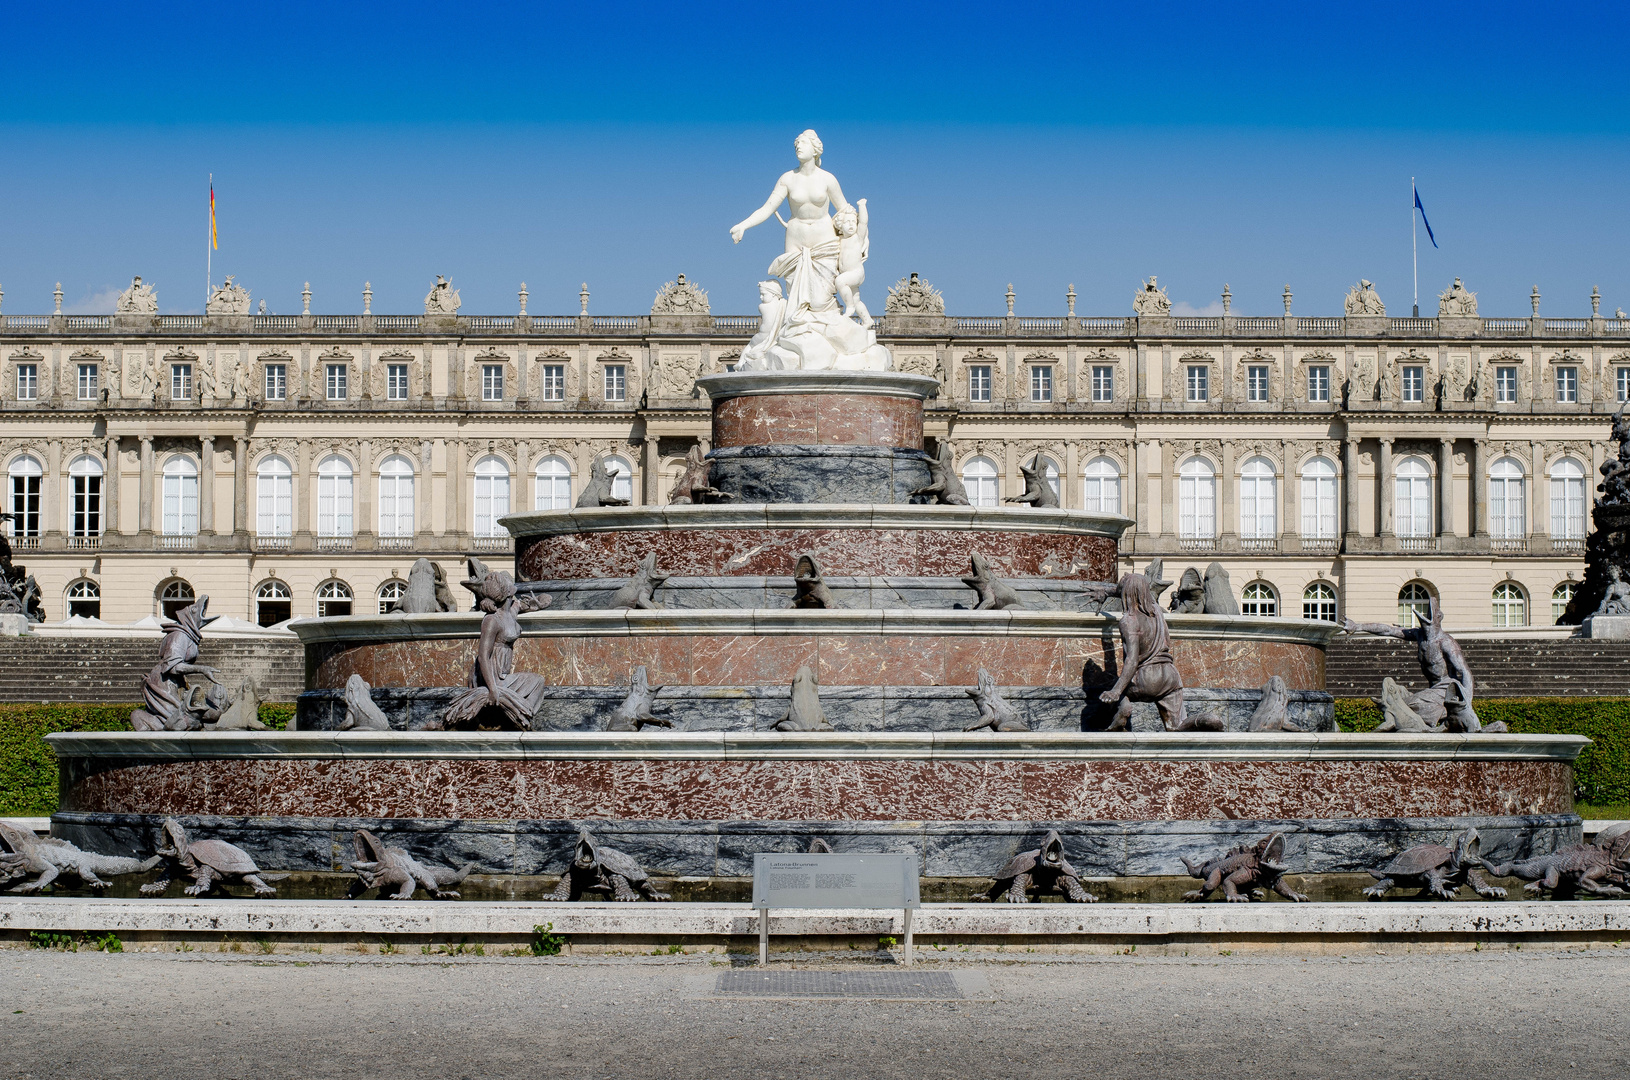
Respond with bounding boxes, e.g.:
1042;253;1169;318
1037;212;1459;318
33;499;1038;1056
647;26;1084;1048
443;557;548;731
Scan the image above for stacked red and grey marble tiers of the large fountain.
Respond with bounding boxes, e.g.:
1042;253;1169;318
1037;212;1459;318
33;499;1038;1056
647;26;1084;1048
52;371;1584;899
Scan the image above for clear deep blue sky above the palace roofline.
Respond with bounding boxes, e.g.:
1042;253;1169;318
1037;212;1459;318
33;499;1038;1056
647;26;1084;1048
0;3;1630;316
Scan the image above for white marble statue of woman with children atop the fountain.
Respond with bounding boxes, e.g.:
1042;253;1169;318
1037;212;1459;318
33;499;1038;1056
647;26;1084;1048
730;130;893;371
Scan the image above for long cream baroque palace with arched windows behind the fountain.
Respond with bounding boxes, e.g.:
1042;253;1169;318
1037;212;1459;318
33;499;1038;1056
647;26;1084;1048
0;275;1630;627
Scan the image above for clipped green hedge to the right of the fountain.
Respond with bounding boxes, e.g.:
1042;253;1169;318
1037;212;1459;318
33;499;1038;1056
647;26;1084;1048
1335;697;1630;805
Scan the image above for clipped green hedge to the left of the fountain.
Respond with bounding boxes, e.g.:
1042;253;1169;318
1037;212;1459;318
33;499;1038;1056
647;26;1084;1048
0;704;295;818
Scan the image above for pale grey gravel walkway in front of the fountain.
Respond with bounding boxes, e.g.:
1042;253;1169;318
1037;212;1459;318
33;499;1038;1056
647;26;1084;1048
0;945;1630;1080
